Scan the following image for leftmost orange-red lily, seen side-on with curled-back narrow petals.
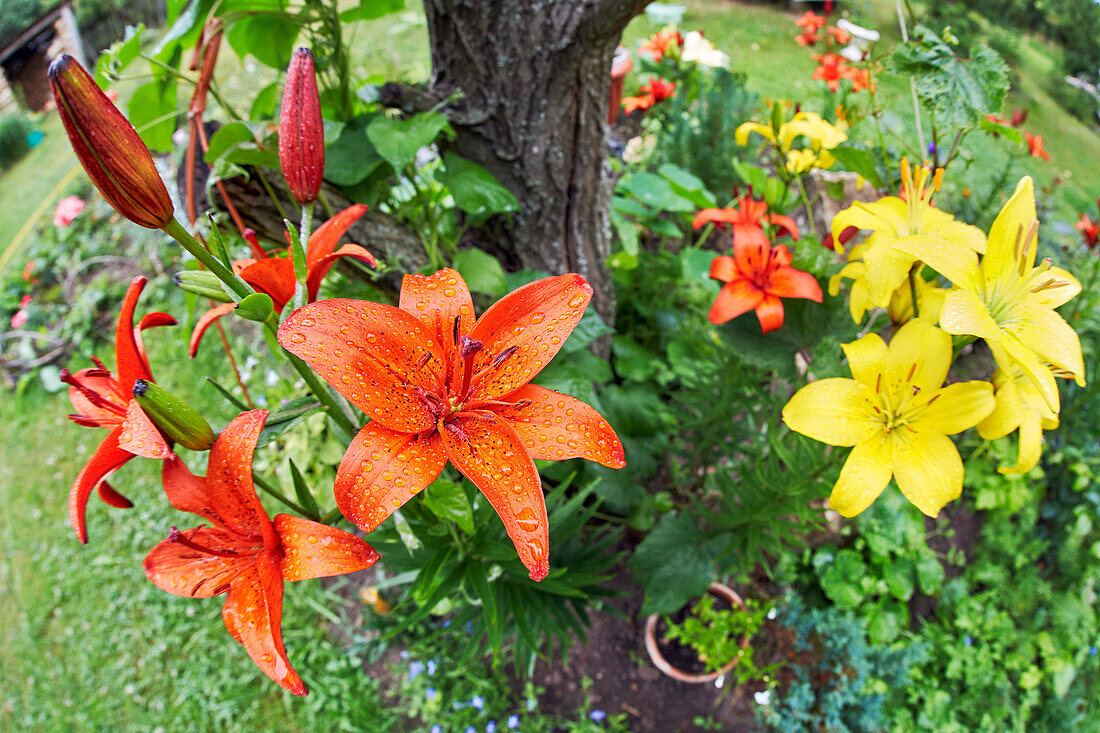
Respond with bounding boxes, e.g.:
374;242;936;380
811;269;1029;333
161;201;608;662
61;277;176;544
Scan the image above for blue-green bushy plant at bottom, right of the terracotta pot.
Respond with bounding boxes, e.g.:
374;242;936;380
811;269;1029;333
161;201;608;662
756;597;924;733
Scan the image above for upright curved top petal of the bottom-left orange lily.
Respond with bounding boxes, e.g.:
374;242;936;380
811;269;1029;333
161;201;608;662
206;409;274;544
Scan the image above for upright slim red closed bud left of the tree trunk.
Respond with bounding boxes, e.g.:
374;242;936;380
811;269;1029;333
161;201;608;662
278;48;325;204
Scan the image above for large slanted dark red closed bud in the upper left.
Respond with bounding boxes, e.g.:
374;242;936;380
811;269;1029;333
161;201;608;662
47;54;173;229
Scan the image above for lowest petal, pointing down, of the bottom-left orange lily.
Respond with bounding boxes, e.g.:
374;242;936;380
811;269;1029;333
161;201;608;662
221;553;307;694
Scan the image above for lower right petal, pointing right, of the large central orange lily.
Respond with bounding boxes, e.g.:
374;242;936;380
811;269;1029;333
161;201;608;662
493;384;626;468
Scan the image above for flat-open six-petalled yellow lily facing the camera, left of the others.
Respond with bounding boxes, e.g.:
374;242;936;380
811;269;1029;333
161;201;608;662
783;319;994;516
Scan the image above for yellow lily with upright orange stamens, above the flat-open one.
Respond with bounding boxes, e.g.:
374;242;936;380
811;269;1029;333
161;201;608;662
833;158;986;308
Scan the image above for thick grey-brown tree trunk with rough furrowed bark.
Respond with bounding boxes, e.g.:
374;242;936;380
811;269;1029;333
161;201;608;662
415;0;648;322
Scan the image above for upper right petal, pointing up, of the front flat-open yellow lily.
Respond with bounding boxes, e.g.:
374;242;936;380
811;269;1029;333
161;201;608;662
881;319;954;400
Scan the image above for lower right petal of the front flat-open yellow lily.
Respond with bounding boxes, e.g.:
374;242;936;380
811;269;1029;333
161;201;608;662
893;429;963;516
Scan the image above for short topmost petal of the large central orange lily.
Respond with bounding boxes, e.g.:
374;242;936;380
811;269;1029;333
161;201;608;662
399;267;474;390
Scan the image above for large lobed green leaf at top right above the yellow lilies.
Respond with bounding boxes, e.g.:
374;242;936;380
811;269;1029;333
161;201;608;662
890;26;1009;131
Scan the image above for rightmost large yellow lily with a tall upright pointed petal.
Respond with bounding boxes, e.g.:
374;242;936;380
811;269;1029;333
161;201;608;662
897;177;1085;412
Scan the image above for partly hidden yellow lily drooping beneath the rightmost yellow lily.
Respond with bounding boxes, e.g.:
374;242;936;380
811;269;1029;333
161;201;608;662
978;343;1058;473
